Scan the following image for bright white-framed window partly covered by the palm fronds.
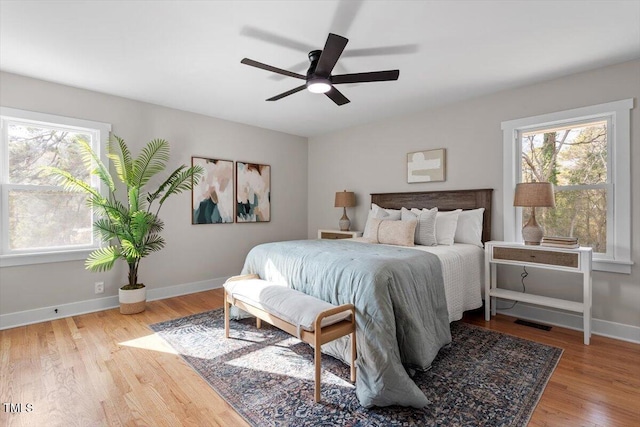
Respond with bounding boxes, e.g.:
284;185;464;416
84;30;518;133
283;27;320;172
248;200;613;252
0;108;110;266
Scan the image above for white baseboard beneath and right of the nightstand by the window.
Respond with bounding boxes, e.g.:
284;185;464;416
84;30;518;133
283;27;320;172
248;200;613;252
497;303;640;344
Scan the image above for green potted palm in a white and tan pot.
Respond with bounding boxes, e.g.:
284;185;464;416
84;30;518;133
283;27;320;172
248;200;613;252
48;135;204;314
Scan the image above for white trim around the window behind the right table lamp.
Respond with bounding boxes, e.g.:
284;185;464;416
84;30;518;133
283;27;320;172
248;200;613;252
502;98;633;274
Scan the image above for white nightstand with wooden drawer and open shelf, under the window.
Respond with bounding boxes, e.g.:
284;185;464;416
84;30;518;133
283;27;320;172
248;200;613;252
484;241;593;344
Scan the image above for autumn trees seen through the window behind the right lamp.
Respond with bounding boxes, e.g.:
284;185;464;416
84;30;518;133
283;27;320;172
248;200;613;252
520;120;610;254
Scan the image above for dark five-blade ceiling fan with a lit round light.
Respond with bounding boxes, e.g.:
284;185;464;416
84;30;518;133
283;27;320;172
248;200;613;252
240;33;400;105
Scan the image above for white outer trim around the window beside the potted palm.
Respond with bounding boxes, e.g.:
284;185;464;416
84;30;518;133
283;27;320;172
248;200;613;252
0;107;111;268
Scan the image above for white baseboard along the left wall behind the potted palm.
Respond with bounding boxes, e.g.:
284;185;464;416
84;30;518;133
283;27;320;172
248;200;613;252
0;277;227;330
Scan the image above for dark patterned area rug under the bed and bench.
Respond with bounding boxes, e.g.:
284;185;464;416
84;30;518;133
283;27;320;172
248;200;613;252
151;309;562;427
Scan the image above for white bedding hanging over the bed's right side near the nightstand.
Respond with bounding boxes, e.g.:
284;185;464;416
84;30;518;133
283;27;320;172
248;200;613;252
351;237;484;322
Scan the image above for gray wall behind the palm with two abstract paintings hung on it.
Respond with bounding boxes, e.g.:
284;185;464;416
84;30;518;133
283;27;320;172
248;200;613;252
0;73;307;315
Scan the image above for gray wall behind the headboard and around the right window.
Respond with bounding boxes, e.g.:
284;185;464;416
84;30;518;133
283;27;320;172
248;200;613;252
308;61;640;327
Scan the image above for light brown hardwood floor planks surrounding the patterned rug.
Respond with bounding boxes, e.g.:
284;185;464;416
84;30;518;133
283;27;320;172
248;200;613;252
0;289;640;427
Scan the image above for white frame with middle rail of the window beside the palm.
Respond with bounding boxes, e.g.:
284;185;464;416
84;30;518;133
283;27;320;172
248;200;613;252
0;107;111;267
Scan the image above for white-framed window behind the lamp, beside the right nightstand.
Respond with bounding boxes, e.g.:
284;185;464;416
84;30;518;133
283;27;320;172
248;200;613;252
502;99;633;274
